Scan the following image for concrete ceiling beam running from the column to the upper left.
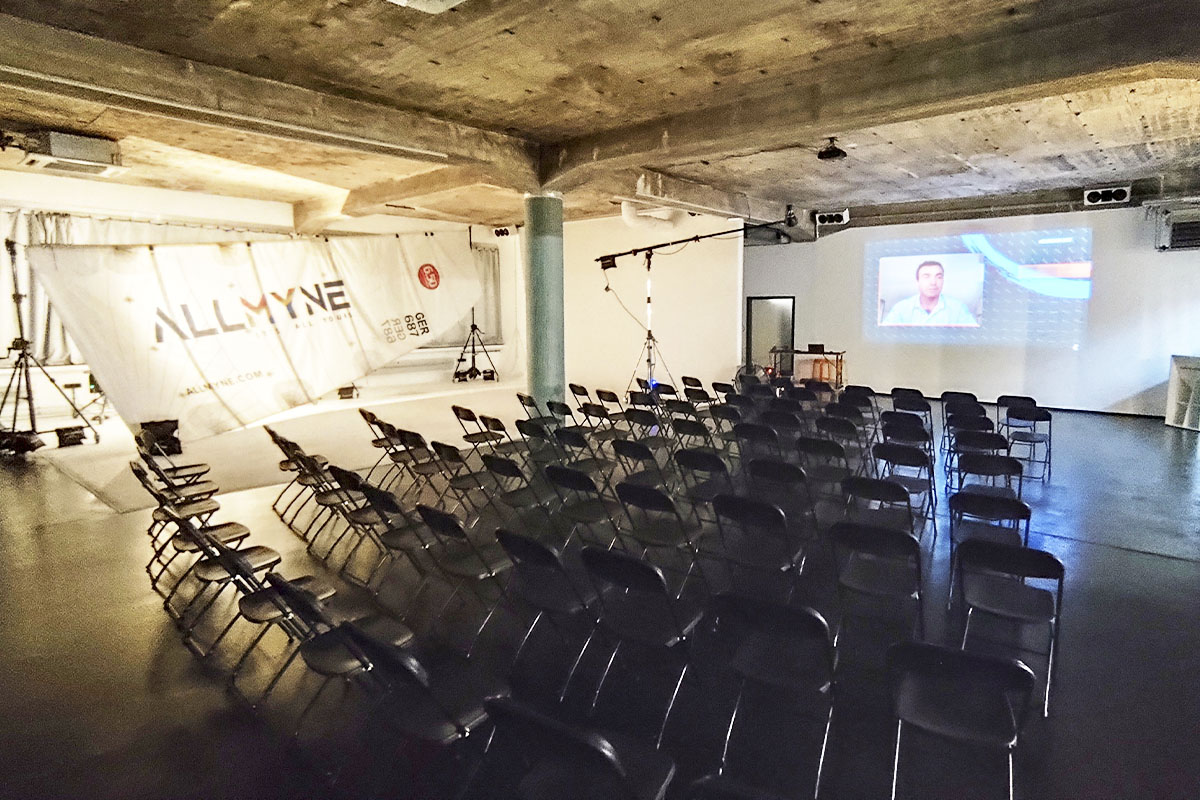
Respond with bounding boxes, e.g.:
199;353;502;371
0;14;538;191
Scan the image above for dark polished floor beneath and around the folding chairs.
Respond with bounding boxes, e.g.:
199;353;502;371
0;413;1200;800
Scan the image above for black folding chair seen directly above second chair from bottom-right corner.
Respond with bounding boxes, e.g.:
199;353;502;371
710;494;809;602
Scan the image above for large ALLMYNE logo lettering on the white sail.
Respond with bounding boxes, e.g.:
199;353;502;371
155;281;350;343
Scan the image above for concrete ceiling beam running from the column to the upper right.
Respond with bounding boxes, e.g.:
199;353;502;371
540;0;1200;192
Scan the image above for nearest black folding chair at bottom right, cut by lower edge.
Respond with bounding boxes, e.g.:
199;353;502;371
888;642;1034;800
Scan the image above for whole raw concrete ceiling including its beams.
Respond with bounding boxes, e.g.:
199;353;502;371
0;0;1200;231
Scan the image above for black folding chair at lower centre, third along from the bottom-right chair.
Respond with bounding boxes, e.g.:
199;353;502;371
568;546;702;747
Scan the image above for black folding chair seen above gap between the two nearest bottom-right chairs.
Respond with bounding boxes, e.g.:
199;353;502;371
829;521;925;640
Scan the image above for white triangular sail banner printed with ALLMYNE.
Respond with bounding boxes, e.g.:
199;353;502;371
26;233;481;439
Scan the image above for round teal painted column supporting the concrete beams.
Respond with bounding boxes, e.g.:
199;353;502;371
522;194;566;403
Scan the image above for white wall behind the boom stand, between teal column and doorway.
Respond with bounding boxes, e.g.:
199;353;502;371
563;216;743;393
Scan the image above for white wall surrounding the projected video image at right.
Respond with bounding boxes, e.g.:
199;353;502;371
745;209;1200;416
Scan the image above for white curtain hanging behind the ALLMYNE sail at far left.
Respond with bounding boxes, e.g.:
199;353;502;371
0;209;292;365
